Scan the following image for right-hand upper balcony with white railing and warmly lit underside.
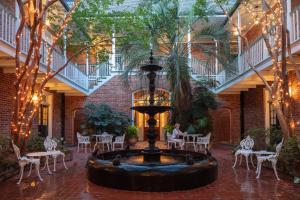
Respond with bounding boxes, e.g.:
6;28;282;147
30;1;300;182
214;5;300;94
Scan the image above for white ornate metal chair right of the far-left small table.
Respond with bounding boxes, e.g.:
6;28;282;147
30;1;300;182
44;136;68;172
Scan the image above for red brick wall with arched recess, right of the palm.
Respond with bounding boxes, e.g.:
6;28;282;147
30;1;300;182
211;94;241;144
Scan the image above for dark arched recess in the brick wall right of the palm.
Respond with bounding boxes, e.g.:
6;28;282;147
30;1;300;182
213;108;231;144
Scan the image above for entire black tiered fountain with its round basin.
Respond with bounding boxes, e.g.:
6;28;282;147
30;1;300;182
87;51;218;192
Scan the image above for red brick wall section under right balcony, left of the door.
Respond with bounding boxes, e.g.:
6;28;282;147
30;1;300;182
243;86;265;132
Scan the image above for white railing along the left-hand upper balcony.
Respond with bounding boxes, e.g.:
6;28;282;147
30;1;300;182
0;4;88;91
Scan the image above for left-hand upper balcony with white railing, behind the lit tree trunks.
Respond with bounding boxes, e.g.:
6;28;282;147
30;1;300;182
0;4;88;94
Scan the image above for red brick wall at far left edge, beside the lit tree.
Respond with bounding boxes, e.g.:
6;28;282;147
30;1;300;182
0;69;16;133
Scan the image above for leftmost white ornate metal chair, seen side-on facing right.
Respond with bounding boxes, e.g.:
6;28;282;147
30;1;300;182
12;143;43;184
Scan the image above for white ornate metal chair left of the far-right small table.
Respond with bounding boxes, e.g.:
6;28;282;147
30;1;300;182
232;135;254;170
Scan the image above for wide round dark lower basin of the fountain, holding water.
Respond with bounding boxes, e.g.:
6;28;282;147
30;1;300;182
87;150;218;192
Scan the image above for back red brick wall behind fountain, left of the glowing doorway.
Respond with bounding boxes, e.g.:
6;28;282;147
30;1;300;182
65;76;169;143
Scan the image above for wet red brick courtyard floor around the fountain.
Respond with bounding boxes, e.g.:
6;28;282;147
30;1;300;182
0;145;300;200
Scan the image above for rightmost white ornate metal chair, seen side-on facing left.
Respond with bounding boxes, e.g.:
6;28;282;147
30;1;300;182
256;139;283;180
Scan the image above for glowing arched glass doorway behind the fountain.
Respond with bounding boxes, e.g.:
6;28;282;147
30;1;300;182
132;89;170;141
